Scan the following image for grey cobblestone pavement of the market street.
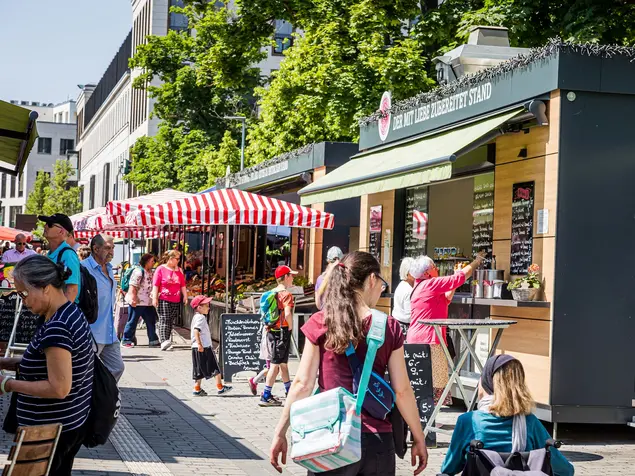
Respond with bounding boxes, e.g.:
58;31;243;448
0;333;635;476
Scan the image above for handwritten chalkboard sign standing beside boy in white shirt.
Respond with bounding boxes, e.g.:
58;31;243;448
220;314;265;382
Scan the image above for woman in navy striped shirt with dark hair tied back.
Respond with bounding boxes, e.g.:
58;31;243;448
0;255;95;475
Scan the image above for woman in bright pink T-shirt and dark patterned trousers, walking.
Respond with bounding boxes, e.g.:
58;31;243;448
152;250;187;350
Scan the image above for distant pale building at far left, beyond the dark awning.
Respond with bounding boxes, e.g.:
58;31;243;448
0;100;77;227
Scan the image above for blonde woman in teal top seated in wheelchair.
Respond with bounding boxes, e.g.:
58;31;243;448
441;355;574;476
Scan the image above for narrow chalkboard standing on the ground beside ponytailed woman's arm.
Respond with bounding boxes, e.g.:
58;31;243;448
404;344;435;442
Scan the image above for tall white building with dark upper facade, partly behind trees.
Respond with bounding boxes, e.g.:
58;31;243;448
77;0;292;210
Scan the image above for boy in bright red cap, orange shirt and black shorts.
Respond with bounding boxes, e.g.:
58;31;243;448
258;266;298;407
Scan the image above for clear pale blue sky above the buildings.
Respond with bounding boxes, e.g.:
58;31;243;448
0;0;132;104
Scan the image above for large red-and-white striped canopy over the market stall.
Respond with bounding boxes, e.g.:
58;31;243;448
126;189;335;230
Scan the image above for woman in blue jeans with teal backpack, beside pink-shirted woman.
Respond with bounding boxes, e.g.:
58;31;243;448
121;253;160;347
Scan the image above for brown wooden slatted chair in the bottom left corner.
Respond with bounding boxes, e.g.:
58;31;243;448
2;423;62;476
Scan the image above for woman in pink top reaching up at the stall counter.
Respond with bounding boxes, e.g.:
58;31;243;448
406;255;483;405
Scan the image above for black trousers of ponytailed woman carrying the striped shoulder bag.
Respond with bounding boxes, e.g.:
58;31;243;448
308;433;395;476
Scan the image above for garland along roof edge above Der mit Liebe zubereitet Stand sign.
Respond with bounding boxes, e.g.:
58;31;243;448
359;37;635;126
